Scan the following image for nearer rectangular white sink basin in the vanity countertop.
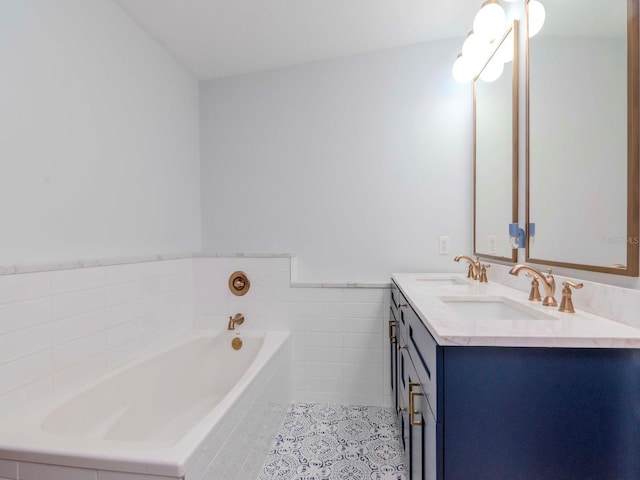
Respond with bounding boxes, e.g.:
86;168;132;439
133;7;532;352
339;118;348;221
438;296;554;320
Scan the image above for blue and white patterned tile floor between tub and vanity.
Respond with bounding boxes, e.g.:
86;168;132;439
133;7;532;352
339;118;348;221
258;403;407;480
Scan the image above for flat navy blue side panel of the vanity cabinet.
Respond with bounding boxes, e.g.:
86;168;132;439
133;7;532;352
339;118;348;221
443;347;640;480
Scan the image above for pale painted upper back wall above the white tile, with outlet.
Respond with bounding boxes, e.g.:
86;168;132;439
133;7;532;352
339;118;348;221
201;39;476;281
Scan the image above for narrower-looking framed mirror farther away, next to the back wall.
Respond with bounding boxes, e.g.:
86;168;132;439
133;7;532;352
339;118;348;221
473;22;518;262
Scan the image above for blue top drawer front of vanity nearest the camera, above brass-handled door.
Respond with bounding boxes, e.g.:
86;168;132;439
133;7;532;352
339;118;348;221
404;308;442;422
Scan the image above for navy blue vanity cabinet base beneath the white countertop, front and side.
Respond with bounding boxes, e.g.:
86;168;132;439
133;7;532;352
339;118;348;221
394;282;640;480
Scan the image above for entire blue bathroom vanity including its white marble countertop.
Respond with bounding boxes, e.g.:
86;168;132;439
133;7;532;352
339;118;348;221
389;274;640;480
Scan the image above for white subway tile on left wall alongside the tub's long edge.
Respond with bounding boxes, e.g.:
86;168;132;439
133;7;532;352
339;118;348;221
0;257;193;420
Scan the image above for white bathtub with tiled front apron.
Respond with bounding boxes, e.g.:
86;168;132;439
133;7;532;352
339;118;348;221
0;330;291;480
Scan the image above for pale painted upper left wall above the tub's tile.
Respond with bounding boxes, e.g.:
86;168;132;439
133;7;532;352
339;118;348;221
0;0;200;264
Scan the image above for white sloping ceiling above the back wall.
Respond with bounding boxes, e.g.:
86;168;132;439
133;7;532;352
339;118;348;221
114;0;482;80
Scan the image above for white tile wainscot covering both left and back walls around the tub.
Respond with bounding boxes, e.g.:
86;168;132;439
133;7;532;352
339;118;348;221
0;253;390;421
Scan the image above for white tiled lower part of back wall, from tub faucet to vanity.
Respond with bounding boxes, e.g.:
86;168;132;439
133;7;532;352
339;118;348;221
193;254;391;406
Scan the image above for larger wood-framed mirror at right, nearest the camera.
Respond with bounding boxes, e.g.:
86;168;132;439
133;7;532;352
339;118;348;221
526;0;639;276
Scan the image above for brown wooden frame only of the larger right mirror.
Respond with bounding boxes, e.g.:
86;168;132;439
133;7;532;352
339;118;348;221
525;0;640;277
